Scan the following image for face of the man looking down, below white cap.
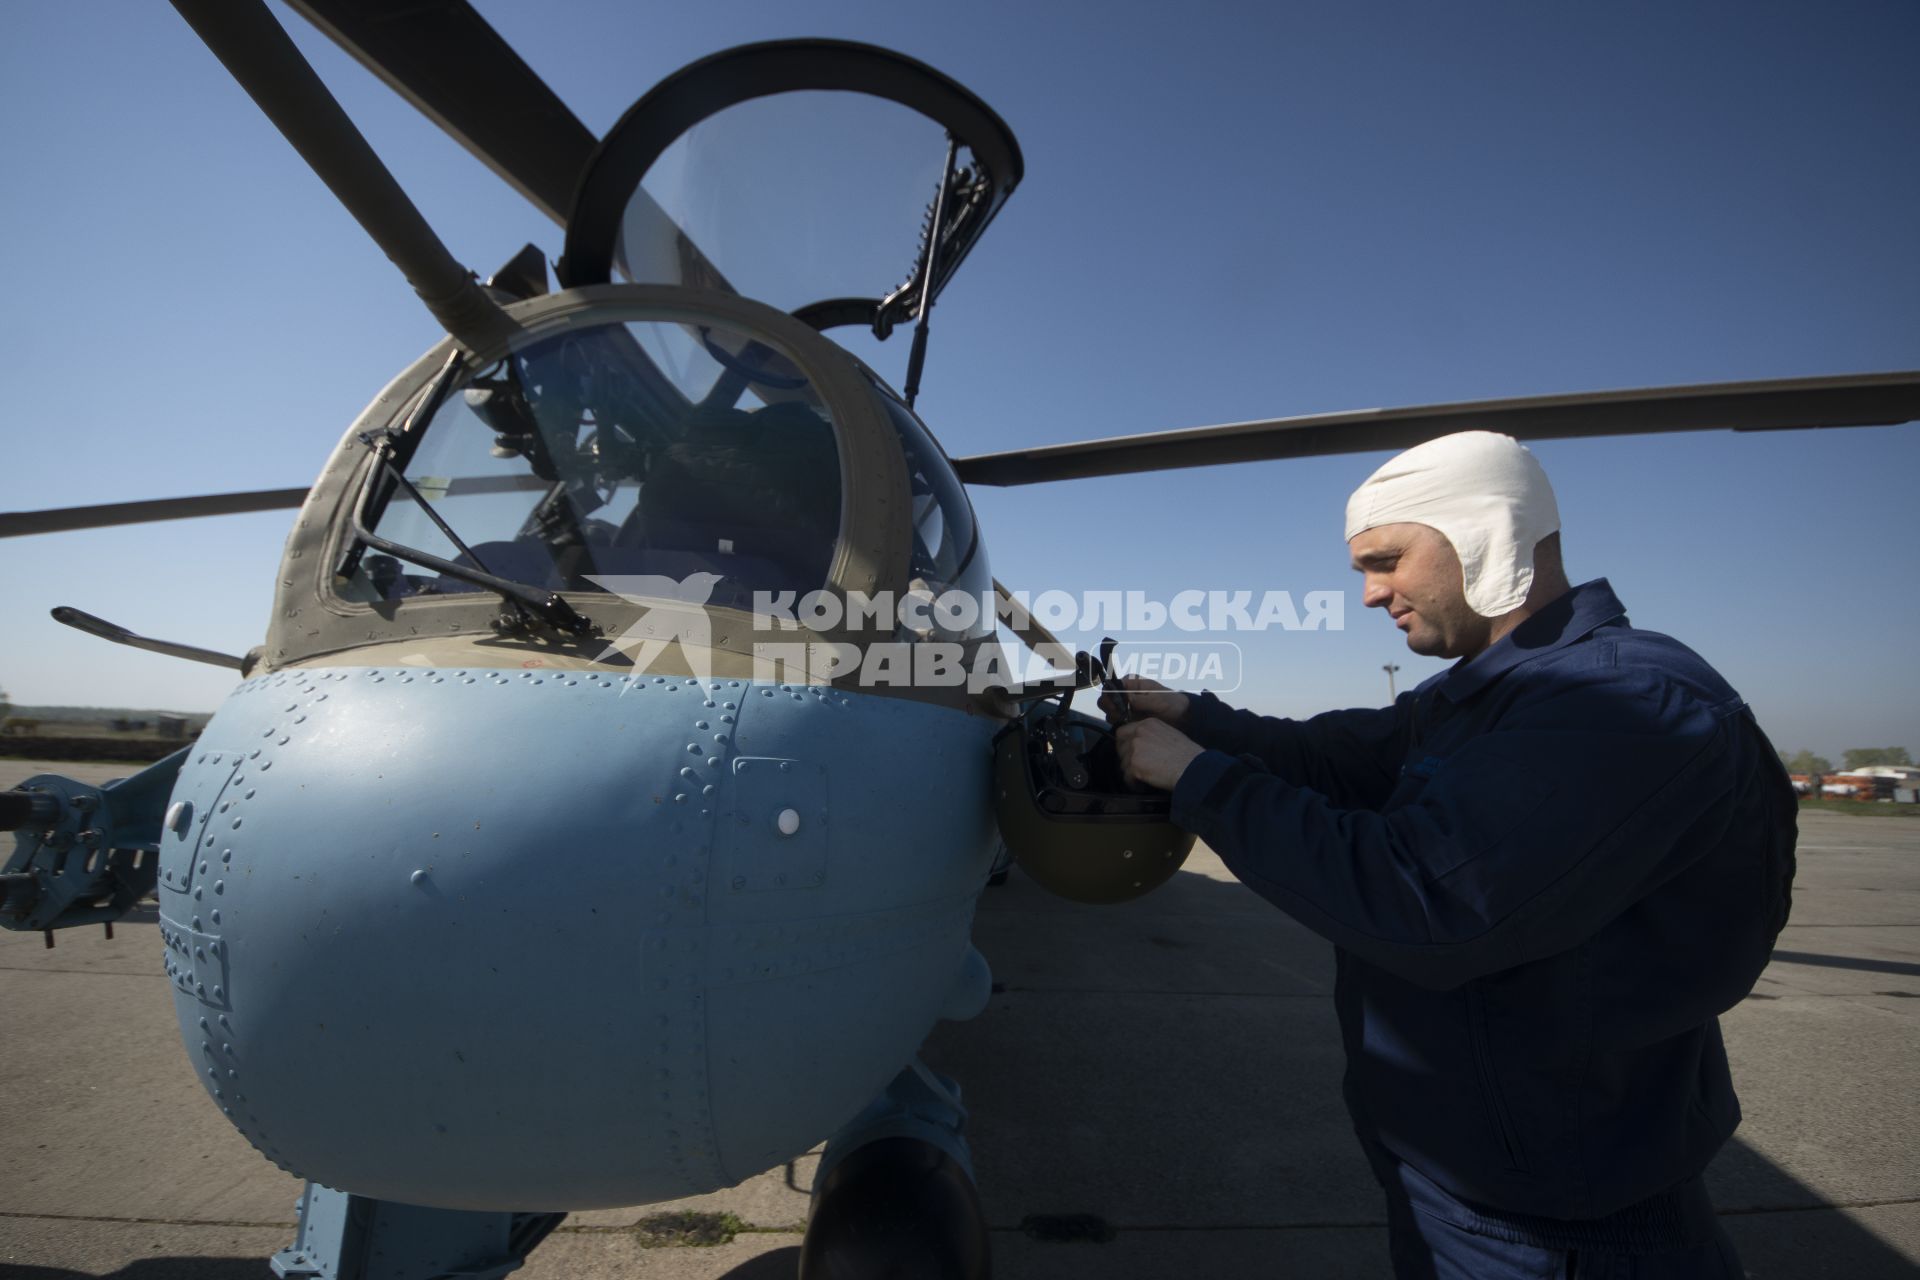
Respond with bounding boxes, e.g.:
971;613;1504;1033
1346;524;1494;658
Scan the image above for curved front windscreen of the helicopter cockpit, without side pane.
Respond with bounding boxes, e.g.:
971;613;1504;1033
357;320;841;608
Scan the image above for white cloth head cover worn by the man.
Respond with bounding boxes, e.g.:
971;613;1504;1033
1346;432;1559;618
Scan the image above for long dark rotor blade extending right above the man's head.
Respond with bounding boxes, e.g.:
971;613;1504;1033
954;370;1920;486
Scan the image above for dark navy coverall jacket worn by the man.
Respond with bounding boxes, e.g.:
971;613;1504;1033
1173;580;1797;1238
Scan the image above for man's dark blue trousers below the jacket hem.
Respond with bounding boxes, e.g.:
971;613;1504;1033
1361;1138;1747;1280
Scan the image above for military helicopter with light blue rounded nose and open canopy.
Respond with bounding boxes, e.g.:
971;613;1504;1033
8;4;1916;1274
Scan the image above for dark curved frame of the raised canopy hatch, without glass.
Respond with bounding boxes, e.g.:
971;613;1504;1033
559;40;1025;330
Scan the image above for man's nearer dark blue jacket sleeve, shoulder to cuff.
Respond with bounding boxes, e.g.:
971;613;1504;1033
1173;676;1740;990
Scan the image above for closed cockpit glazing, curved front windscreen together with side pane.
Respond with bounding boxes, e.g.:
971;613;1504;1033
334;309;993;640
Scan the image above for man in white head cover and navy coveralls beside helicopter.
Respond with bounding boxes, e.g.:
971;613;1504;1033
1102;432;1795;1280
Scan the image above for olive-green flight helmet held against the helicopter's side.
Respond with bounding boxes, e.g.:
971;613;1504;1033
993;700;1194;904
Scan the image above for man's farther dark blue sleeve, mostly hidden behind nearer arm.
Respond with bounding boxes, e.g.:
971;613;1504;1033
1179;693;1415;808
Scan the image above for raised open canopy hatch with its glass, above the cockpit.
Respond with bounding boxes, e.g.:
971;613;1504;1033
561;40;1021;336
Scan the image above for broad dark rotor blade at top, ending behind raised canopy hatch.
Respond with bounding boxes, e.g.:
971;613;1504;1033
288;0;599;226
